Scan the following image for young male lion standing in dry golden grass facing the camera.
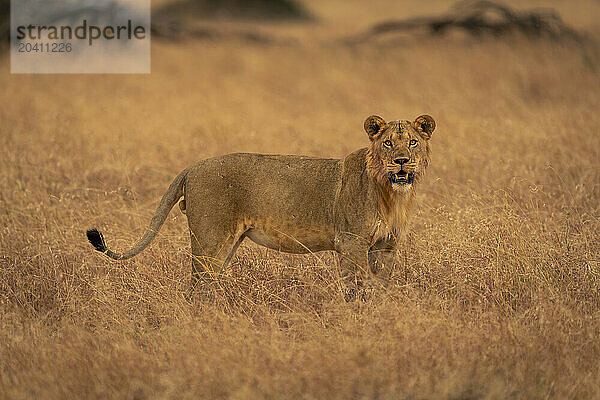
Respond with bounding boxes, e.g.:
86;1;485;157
87;115;436;298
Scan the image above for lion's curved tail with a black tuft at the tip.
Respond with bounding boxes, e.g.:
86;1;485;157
86;169;188;260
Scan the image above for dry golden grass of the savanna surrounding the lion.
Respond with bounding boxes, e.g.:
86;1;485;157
0;0;600;399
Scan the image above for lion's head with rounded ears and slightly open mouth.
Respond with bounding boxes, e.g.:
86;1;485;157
365;115;435;191
